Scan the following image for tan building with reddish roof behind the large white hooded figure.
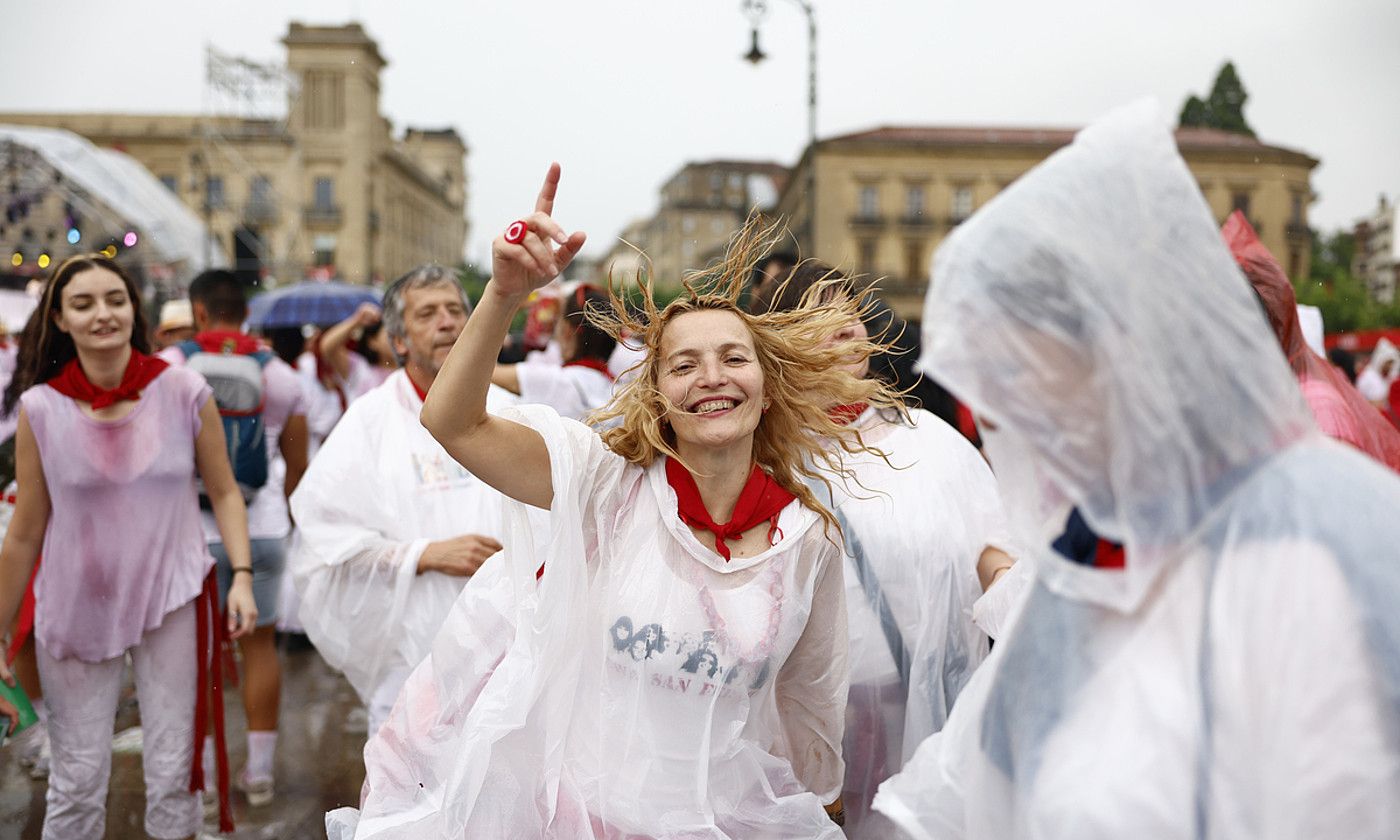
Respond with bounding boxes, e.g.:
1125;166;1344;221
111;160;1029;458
773;126;1319;318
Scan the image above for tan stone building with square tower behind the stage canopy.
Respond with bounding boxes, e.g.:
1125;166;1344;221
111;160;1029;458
0;22;468;283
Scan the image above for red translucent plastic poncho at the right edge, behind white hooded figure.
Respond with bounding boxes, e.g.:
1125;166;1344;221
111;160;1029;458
1221;210;1400;470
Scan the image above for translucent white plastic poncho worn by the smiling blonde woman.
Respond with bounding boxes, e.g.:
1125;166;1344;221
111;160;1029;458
326;406;847;840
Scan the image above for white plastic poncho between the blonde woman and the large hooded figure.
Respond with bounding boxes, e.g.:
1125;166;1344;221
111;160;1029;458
813;409;1008;839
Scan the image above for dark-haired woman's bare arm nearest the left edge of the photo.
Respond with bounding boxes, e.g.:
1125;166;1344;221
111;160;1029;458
0;409;52;686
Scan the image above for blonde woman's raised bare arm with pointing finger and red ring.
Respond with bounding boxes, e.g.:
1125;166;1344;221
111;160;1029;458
421;164;584;508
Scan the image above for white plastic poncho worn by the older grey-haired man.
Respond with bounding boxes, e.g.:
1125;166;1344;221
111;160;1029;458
291;370;514;734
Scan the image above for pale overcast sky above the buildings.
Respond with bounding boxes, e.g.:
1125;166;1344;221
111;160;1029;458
0;0;1400;263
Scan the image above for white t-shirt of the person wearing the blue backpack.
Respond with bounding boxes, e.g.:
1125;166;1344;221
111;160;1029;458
160;344;307;543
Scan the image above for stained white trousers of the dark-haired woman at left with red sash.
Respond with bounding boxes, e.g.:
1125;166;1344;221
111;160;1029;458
38;602;203;840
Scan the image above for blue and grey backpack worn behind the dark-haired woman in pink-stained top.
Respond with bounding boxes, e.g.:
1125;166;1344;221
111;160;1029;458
179;342;272;508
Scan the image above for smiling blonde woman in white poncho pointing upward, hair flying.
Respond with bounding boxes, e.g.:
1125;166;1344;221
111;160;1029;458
326;165;899;840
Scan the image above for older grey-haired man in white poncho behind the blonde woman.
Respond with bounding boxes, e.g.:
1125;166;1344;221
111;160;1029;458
291;265;514;735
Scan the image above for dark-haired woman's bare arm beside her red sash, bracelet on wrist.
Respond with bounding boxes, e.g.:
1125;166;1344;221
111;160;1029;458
195;398;258;638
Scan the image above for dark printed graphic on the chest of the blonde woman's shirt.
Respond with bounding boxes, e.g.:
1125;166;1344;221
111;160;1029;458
608;616;770;697
